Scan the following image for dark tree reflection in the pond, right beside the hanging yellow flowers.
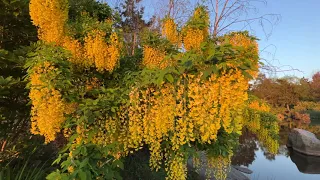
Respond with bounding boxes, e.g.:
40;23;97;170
232;129;258;166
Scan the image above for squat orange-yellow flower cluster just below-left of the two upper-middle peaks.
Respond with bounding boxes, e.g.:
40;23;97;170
142;46;170;69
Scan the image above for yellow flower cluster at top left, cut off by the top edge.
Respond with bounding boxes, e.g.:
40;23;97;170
30;0;68;45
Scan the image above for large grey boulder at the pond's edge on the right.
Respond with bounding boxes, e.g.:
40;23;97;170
287;128;320;156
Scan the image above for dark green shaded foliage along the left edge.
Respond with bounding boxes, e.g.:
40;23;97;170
0;0;37;161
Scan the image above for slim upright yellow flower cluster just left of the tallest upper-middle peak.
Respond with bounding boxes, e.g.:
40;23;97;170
162;18;181;46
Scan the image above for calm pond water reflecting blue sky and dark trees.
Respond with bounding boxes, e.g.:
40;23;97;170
232;132;320;180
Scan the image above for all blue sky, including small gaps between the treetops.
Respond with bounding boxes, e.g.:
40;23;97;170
109;0;320;78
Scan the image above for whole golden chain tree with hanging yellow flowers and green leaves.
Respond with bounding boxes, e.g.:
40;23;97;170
29;0;277;180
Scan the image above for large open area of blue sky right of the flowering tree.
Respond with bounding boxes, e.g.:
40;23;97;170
251;0;320;77
